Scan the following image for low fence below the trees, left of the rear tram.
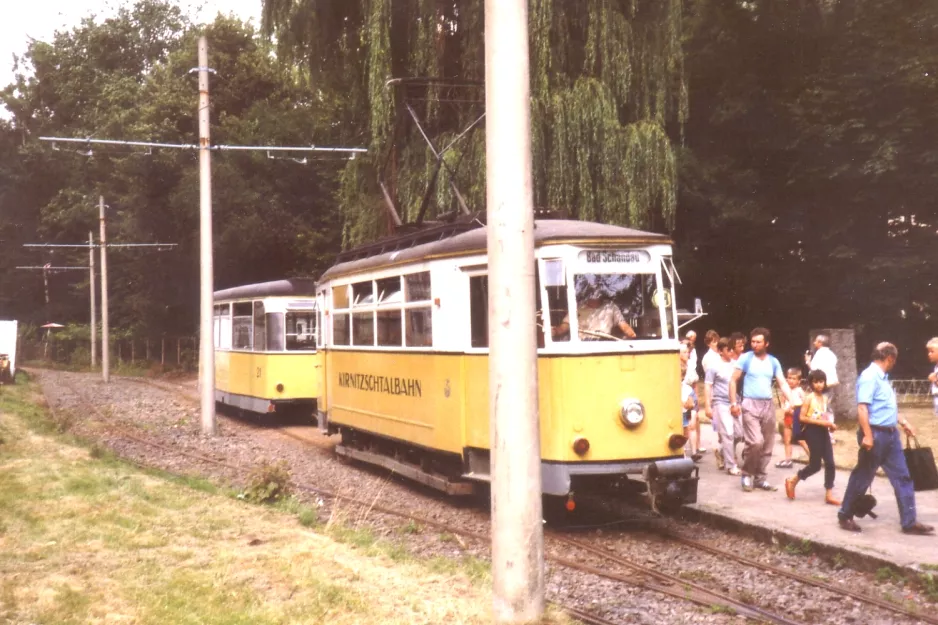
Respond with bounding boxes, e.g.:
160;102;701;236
20;336;199;371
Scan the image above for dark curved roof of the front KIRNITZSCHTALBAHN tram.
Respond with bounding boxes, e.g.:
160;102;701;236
319;219;671;280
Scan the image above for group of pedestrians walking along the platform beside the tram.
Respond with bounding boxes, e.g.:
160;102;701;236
681;327;938;535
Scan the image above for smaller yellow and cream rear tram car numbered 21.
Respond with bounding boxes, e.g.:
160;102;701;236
214;278;322;419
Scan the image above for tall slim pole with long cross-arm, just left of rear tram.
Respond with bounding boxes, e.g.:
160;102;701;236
199;37;216;435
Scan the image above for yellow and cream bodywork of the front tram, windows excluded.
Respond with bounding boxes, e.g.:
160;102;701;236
317;222;683;495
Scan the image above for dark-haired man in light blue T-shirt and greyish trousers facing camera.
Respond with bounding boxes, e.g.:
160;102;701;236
730;328;793;492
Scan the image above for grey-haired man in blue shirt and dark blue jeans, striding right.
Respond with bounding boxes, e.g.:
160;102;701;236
837;343;935;535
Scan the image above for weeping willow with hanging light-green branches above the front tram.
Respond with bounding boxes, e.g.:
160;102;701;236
263;0;687;243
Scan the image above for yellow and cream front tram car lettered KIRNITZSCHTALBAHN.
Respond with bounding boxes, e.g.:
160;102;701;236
317;220;697;507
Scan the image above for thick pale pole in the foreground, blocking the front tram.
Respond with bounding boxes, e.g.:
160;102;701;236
485;0;544;623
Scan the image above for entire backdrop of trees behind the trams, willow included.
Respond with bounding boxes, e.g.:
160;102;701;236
0;0;938;373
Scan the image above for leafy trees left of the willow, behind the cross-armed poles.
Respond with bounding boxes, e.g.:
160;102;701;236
0;0;342;335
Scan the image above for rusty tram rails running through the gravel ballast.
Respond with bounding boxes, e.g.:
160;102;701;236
49;372;938;625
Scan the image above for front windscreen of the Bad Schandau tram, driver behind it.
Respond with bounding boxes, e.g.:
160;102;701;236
552;273;661;341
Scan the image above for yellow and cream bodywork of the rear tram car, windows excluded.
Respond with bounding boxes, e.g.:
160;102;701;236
215;285;323;416
